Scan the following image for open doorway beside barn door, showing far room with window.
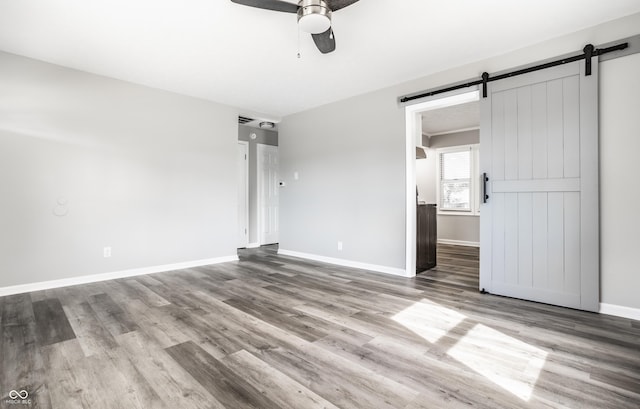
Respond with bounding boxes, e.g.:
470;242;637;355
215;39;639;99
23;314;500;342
416;97;481;290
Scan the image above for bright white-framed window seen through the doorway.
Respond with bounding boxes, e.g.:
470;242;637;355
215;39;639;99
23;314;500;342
437;145;480;215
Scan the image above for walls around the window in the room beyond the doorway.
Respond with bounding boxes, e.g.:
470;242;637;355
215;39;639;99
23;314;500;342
416;130;480;243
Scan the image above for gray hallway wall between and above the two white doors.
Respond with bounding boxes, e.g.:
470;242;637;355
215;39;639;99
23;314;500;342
238;125;278;244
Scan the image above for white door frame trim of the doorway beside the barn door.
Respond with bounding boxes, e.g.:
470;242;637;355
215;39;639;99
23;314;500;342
405;85;482;277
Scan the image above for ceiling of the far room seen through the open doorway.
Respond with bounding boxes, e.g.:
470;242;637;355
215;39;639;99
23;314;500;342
422;101;480;136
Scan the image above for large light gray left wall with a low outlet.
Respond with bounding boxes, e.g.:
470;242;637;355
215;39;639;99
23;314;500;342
0;53;238;287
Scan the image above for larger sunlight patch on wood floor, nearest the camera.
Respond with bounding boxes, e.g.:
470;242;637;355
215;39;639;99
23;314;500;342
447;324;547;401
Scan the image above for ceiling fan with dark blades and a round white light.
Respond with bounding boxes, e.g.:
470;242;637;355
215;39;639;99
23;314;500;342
231;0;358;54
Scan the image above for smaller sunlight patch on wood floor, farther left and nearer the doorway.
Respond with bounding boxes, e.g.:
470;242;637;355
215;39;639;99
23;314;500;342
391;299;467;343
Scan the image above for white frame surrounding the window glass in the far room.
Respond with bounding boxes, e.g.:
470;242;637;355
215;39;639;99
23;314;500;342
436;143;480;216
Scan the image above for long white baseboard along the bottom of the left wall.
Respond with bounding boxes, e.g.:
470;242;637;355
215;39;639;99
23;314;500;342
0;255;238;297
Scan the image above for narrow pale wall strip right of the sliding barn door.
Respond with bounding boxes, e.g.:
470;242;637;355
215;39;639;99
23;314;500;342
600;54;640;309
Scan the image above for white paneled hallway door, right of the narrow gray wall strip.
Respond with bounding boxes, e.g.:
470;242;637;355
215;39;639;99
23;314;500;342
258;144;279;245
